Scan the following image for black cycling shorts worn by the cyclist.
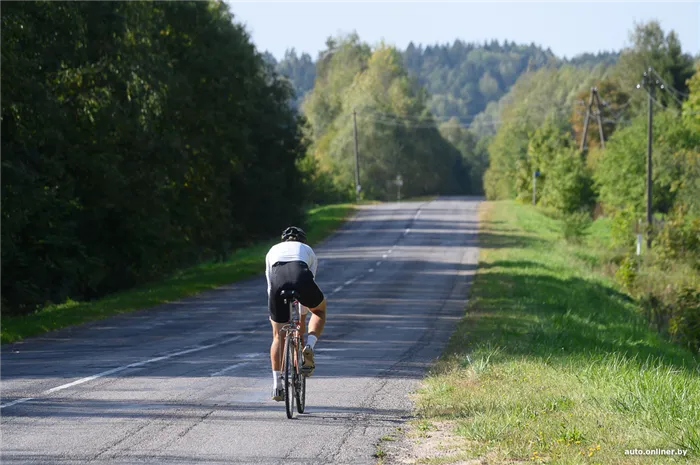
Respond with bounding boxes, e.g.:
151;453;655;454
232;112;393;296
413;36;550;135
268;262;324;323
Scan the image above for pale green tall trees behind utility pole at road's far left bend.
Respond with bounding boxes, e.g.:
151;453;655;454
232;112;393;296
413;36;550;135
303;35;469;199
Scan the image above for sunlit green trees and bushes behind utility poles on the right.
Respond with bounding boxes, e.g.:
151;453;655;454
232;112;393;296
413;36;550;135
484;21;700;350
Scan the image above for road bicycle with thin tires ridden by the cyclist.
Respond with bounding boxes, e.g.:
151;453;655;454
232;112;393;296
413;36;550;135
280;290;306;419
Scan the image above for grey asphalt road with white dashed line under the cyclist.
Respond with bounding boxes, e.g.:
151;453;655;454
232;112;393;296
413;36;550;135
0;198;478;464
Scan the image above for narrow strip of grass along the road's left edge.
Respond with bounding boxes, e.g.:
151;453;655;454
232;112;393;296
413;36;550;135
0;204;354;343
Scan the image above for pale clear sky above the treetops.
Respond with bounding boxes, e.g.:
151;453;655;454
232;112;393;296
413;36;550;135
225;0;700;59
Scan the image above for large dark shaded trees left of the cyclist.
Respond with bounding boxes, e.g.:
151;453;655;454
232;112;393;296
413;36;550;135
0;0;305;313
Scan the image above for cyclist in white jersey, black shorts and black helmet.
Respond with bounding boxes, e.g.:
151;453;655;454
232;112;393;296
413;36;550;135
265;226;326;401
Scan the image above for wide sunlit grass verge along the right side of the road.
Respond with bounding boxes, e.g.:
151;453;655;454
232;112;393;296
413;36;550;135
416;202;700;464
